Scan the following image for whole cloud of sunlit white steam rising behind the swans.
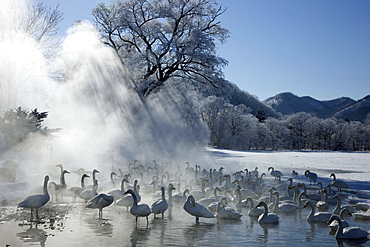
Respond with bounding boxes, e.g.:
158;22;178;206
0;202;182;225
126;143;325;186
0;0;207;189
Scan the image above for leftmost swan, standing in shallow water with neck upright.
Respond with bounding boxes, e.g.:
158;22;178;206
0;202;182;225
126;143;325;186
18;175;50;221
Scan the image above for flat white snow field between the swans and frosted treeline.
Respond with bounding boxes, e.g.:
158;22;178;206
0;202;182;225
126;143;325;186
208;148;370;181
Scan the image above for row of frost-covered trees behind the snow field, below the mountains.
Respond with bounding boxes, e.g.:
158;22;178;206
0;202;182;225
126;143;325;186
199;97;370;151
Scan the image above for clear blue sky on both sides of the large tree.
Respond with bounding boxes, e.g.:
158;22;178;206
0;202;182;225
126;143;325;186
33;0;370;100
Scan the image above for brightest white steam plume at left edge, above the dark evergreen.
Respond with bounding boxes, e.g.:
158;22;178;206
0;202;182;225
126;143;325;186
0;0;53;113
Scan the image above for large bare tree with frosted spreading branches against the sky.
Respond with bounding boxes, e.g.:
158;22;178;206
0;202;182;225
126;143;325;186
93;0;229;96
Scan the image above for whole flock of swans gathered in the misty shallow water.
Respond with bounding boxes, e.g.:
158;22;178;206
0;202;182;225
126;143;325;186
14;160;369;243
